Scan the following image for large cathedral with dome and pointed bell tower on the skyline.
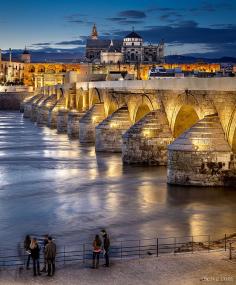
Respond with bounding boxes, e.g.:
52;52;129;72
86;25;164;64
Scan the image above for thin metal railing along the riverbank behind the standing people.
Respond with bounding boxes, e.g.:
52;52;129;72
0;232;234;268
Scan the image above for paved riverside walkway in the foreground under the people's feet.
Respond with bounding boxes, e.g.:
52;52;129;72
0;252;236;285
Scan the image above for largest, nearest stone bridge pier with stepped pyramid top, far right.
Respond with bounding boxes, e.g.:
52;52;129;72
167;115;235;186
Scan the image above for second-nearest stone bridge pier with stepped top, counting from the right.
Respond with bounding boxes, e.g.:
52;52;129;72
122;110;173;165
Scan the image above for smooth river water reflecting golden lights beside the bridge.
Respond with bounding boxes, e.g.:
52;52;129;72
0;112;236;247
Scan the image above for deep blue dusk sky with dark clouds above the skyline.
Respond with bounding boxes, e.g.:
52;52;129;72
0;0;236;57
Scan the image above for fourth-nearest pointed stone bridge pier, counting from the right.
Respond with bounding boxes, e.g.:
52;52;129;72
79;103;105;143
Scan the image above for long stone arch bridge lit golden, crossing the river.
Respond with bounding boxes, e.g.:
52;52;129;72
20;78;236;187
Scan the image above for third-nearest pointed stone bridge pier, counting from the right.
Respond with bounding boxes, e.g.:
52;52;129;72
95;106;132;152
